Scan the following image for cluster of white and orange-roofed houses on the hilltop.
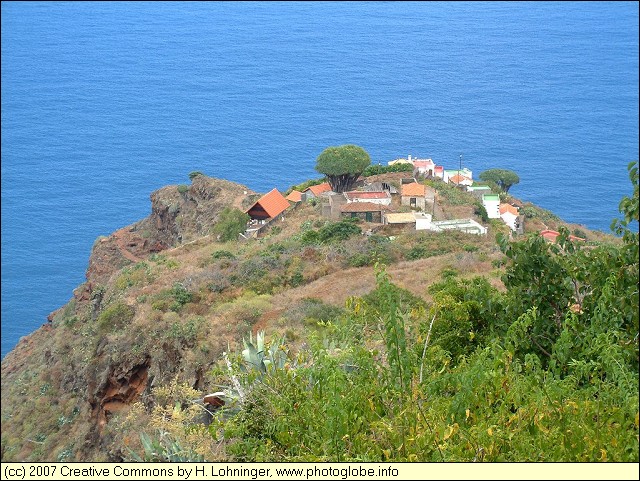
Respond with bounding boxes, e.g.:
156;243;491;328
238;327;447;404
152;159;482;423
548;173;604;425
241;155;579;241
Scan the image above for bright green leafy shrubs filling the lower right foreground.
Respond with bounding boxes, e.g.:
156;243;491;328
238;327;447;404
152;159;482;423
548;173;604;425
131;164;639;462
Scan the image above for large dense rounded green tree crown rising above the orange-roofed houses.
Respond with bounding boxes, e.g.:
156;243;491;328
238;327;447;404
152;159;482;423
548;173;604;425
316;144;371;192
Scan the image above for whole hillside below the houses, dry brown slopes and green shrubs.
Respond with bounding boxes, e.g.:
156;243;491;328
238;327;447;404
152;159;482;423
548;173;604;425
2;168;638;461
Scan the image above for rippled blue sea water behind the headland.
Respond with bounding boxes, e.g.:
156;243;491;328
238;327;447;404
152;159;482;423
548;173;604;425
1;2;638;357
